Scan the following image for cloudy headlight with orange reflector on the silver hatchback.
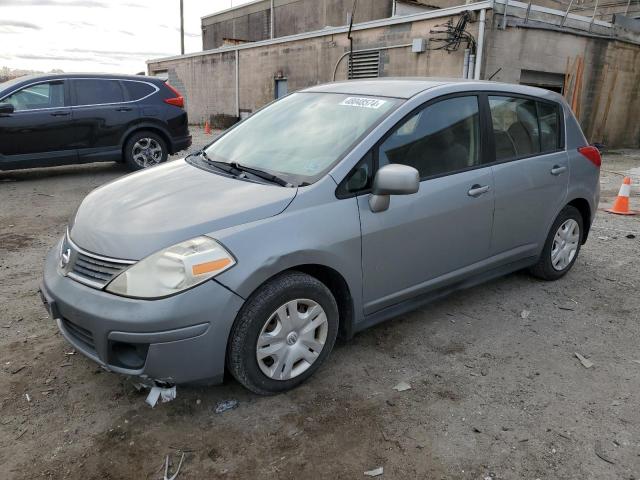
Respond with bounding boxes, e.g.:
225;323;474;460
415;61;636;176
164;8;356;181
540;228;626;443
106;237;236;298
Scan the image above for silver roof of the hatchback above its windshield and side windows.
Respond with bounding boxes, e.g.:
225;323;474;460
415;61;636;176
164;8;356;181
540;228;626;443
302;77;561;100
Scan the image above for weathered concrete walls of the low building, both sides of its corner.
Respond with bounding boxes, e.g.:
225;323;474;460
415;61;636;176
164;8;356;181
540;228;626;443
149;6;640;147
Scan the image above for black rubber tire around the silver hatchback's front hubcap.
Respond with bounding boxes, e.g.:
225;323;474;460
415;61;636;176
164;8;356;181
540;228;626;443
227;271;339;395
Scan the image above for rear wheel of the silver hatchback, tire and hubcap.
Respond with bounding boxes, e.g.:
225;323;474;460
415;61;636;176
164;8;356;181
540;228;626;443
530;205;583;280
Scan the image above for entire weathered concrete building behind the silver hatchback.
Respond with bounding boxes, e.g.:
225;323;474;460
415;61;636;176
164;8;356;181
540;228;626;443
148;0;640;147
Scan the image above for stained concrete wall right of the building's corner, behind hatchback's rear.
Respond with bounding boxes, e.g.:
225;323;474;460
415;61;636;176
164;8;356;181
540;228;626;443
483;10;640;147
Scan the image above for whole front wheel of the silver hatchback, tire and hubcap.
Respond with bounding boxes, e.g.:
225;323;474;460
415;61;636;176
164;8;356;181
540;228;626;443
227;272;338;395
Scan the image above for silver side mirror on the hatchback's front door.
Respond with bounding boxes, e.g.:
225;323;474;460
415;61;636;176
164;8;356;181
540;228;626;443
369;163;420;213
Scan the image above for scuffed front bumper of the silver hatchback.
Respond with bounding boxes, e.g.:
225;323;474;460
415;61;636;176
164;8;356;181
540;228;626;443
40;248;243;384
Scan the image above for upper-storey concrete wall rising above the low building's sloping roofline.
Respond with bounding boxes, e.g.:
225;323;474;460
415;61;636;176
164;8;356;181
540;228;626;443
202;0;393;50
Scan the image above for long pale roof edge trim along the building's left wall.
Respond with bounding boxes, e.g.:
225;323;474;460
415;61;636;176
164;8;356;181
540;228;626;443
146;0;493;64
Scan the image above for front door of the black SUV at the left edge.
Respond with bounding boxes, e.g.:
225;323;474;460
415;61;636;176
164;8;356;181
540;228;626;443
0;80;76;168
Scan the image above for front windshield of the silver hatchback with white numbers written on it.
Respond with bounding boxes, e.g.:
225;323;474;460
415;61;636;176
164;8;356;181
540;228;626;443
205;93;400;185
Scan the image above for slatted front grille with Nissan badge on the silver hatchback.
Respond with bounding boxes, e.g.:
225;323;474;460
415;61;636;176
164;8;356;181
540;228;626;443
63;236;135;289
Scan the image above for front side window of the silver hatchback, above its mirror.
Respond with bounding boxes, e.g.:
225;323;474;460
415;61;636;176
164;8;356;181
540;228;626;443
378;96;480;178
